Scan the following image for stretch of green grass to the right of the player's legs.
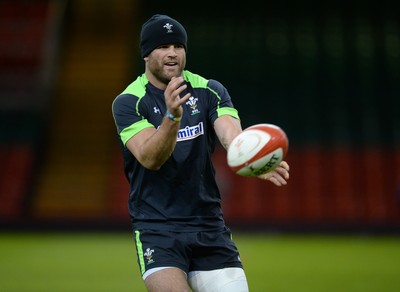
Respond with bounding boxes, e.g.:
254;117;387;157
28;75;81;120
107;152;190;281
237;236;400;292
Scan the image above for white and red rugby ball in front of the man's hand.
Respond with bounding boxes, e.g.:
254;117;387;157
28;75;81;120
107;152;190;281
227;124;289;176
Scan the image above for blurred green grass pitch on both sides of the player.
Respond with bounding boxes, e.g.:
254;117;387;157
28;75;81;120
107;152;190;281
0;232;400;292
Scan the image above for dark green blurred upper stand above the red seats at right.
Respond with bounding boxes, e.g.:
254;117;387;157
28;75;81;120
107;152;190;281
143;0;400;147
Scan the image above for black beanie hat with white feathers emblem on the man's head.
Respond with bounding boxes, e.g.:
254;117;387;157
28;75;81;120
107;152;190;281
140;14;187;58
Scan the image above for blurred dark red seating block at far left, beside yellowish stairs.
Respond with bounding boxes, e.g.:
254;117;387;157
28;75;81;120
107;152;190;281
0;1;50;221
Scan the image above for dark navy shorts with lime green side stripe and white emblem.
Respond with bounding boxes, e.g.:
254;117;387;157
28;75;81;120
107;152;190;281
135;228;242;275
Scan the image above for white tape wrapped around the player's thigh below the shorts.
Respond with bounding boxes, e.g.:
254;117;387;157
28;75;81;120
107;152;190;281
188;268;249;292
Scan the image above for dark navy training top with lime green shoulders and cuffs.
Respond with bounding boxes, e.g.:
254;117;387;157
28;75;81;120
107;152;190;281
112;71;239;232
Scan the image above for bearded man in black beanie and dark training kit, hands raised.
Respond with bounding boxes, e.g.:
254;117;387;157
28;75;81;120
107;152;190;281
112;15;289;292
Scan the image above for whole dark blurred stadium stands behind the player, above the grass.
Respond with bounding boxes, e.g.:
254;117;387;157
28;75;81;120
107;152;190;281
0;0;400;232
